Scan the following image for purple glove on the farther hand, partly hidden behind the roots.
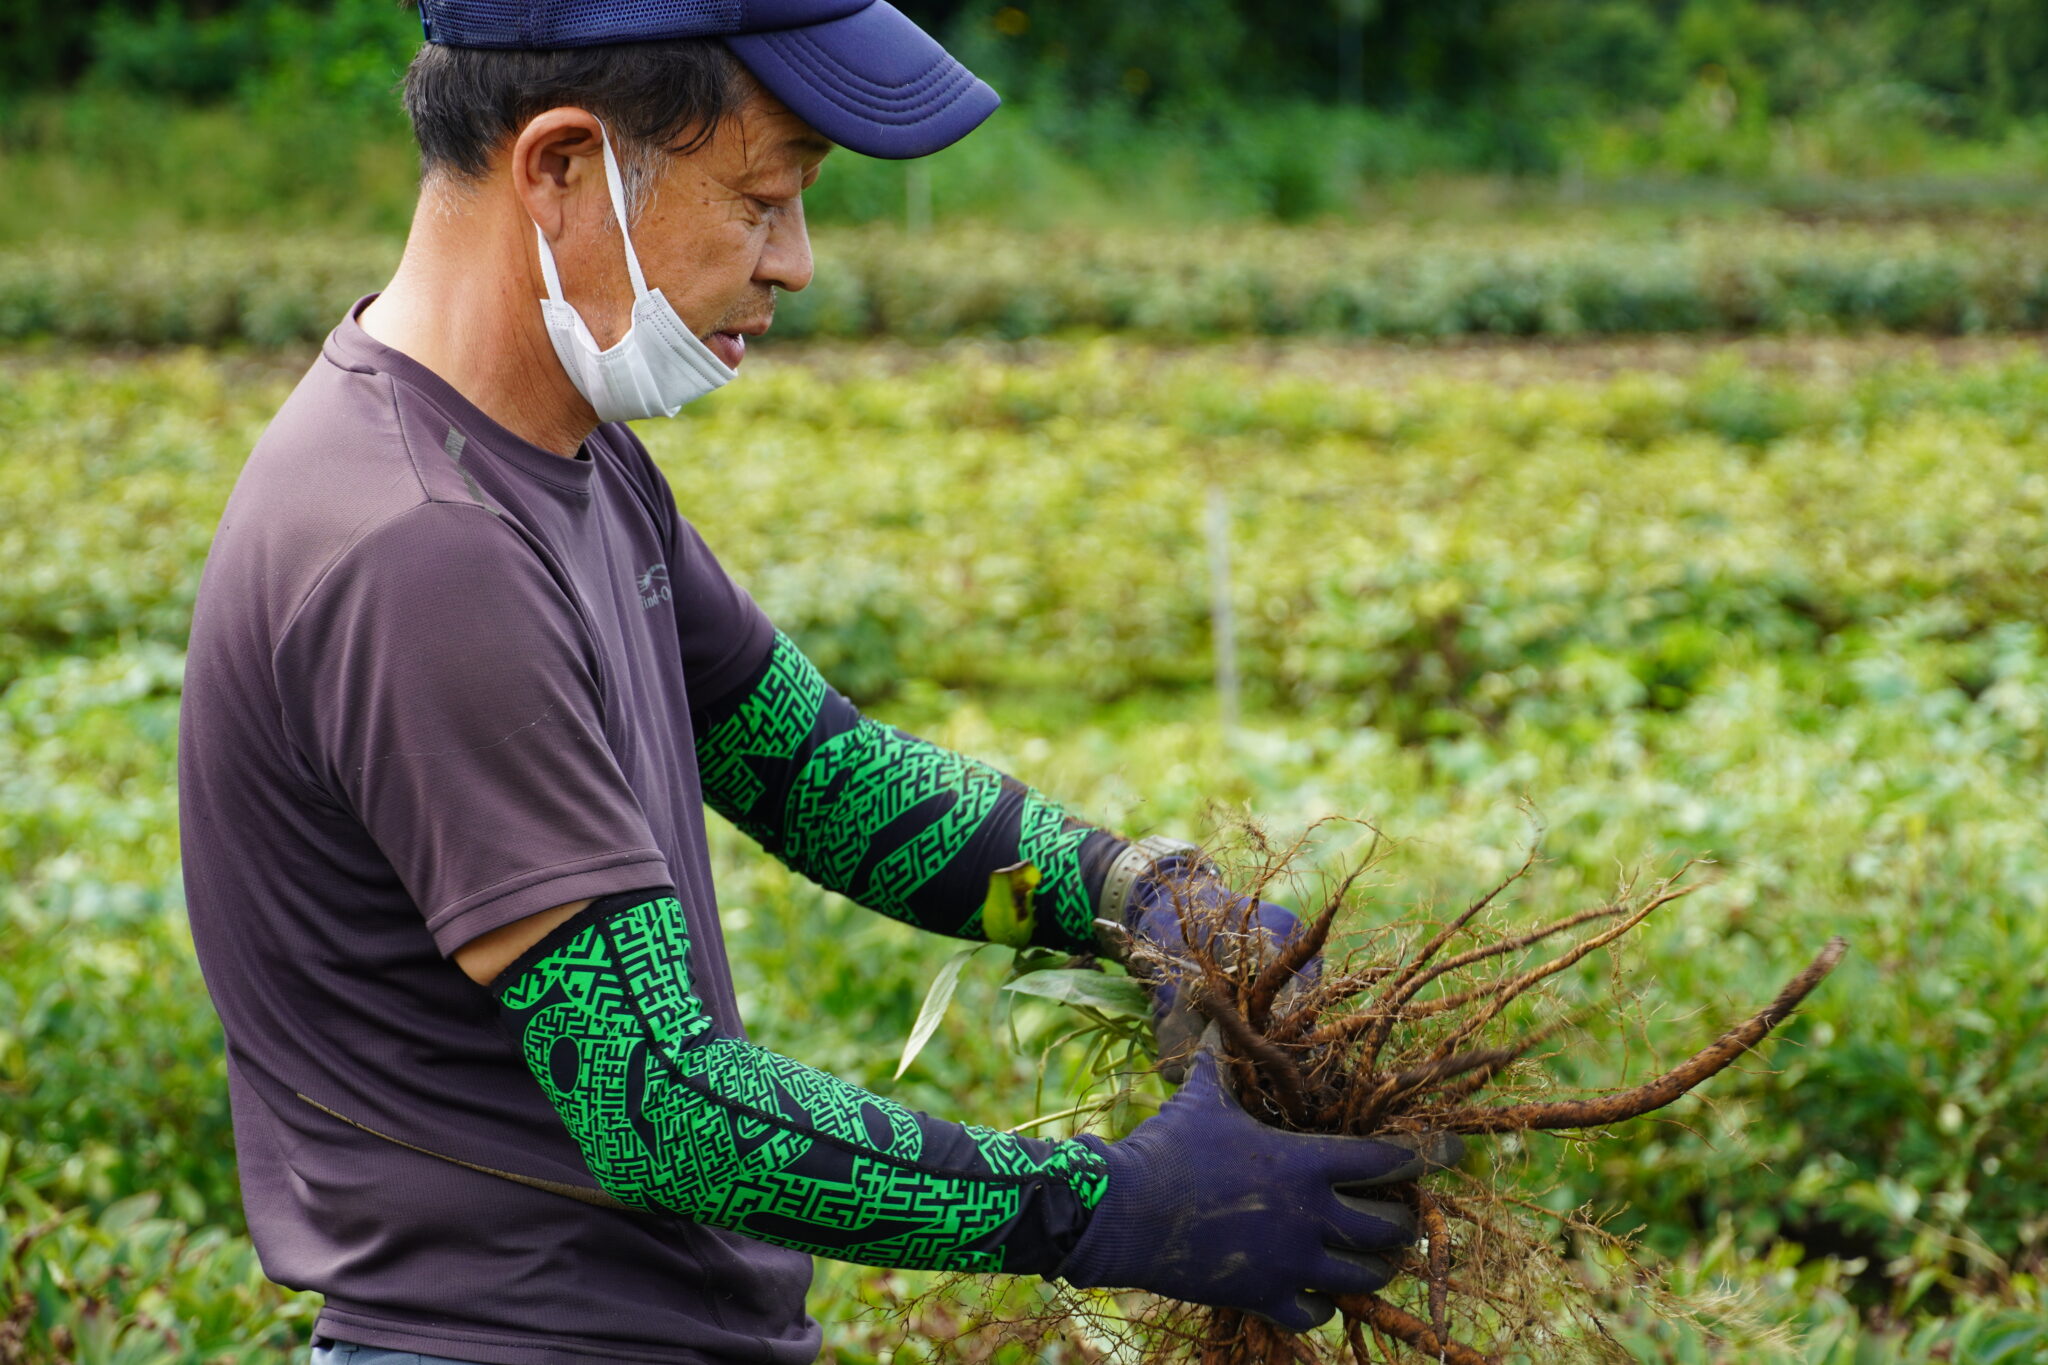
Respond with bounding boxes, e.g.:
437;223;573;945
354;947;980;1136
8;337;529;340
1122;845;1323;1085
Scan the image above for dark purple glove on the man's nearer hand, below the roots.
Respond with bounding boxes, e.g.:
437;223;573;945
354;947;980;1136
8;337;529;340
1057;1048;1464;1332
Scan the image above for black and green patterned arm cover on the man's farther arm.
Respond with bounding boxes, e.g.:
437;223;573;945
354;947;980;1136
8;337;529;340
692;632;1126;954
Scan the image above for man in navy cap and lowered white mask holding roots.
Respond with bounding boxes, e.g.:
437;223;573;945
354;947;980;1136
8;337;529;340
180;0;1444;1365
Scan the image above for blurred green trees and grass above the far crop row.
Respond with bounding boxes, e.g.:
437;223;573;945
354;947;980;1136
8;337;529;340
0;0;2048;239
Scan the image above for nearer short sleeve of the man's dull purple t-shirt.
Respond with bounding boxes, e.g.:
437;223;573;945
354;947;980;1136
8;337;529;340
272;503;668;956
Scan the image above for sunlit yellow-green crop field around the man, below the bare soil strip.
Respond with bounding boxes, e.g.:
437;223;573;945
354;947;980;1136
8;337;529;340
0;335;2048;1365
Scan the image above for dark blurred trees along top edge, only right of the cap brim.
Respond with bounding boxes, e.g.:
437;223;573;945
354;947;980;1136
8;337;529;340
937;0;2048;133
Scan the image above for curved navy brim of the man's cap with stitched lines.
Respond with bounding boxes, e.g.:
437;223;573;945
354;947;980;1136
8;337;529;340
725;0;1001;160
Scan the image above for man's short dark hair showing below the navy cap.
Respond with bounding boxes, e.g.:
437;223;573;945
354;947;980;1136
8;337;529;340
406;39;750;189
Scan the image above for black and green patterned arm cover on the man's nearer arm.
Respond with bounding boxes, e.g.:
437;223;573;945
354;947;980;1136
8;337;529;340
492;888;1108;1275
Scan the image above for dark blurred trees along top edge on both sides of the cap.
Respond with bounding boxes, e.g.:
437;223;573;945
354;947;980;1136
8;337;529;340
12;0;2048;136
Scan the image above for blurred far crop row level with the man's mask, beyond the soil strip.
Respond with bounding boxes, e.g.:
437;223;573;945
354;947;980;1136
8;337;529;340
16;215;2048;347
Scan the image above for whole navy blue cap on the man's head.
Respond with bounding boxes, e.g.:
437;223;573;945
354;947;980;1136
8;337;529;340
420;0;1001;160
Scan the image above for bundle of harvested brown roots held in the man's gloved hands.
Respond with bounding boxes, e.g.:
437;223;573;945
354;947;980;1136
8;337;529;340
888;827;1845;1365
